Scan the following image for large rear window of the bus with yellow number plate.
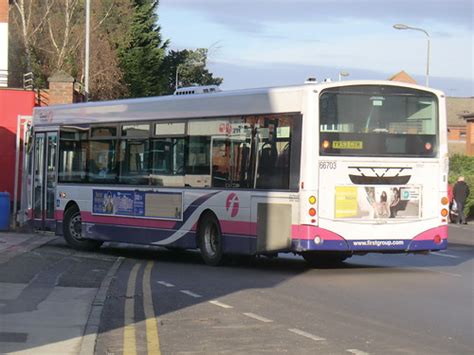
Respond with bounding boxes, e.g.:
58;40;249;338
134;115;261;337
319;85;438;157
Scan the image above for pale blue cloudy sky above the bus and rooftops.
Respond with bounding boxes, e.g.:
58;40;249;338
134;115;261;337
158;0;474;96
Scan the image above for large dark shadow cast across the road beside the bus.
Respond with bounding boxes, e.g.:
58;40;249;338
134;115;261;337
0;232;474;352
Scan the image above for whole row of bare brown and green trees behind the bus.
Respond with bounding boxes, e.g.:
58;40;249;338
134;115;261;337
9;0;222;100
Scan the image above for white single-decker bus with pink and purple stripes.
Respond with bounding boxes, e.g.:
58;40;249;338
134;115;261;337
25;81;448;265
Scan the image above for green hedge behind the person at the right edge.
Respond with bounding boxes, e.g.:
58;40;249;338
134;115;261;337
449;154;474;217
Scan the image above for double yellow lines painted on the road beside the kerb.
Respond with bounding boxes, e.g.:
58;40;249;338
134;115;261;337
123;261;161;355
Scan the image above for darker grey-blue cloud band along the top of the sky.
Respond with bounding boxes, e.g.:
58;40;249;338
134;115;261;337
161;0;474;33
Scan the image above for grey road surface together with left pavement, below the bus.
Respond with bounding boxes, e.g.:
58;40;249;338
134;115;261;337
0;224;474;354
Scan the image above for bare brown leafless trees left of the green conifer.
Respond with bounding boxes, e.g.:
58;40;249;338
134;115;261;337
10;0;133;100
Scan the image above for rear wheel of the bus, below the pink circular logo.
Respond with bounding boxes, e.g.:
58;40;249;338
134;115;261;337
199;214;224;266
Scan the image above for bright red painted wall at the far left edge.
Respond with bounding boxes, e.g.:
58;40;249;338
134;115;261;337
0;89;35;200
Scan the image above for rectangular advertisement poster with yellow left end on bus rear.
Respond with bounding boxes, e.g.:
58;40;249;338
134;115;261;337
335;186;421;220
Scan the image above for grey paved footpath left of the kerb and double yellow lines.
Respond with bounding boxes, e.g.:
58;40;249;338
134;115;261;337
0;232;118;354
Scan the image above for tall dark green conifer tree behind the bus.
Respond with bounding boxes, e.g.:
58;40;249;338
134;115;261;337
119;0;168;97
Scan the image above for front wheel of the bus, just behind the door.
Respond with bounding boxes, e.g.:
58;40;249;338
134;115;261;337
64;206;102;250
